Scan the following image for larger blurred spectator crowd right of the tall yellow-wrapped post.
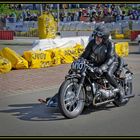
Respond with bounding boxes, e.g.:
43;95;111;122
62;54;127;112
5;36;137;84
54;4;140;22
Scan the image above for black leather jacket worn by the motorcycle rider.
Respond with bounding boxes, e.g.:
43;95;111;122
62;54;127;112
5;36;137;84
80;39;117;66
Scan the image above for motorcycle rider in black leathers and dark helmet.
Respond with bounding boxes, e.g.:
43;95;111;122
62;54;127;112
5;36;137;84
80;26;124;102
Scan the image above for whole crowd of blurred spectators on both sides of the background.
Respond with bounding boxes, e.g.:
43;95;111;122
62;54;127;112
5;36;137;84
1;4;140;23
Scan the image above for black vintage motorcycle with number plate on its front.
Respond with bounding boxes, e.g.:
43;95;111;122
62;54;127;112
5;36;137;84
57;58;134;119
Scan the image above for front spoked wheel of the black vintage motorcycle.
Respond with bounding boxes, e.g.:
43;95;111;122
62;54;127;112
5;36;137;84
58;79;85;119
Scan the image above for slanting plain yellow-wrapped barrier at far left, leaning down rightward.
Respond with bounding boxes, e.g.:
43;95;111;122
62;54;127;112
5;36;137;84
1;47;28;69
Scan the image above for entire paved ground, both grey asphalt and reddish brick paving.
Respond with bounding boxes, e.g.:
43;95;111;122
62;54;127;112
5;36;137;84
0;54;140;136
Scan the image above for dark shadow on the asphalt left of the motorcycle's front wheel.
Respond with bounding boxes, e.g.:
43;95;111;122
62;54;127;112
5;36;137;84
0;103;65;121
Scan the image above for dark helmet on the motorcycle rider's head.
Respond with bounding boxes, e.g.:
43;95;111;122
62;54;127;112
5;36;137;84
93;26;110;41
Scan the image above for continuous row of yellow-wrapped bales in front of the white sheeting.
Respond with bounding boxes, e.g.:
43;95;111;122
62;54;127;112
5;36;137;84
23;44;84;68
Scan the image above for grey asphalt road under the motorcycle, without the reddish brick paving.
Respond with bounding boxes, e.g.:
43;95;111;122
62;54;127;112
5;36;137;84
0;54;140;137
